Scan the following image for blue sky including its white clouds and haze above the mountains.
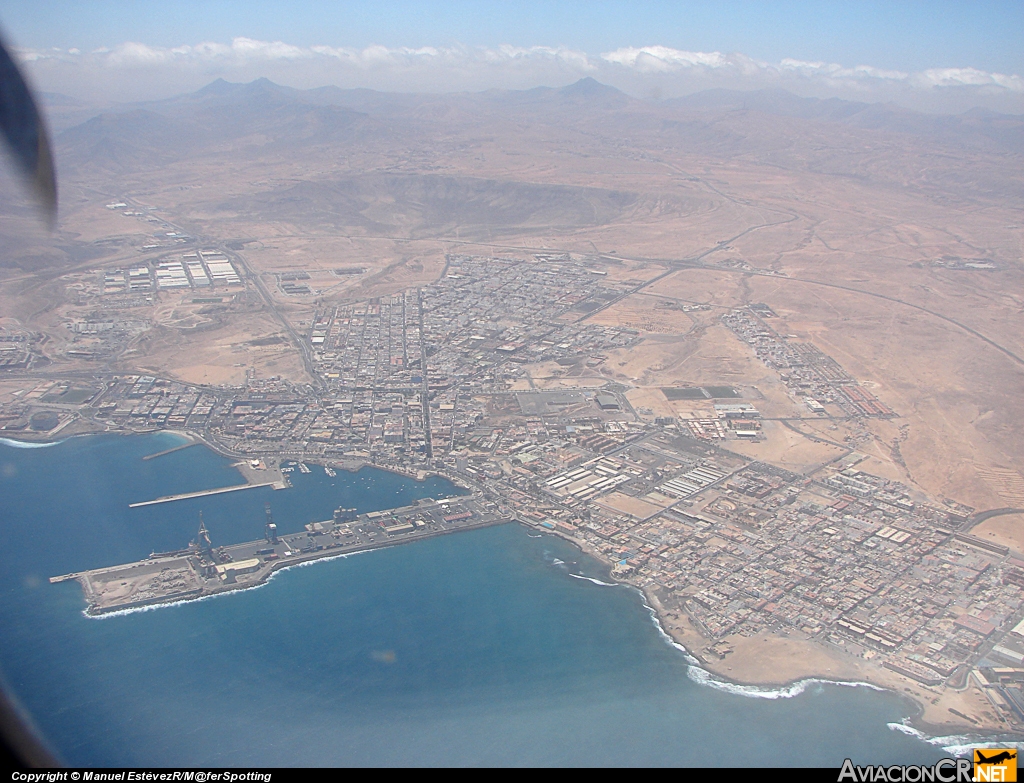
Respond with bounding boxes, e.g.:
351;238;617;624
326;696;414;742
0;0;1024;113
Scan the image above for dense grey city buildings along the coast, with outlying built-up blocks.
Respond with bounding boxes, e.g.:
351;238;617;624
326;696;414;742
6;239;1024;728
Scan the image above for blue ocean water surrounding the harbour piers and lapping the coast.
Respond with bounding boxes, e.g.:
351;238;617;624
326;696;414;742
0;434;945;767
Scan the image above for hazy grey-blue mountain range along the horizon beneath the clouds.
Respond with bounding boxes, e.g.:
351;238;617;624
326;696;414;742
45;78;1024;198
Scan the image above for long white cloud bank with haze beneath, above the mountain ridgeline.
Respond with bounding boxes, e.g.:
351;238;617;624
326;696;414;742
17;38;1024;114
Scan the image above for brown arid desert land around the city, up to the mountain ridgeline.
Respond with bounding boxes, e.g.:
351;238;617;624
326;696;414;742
0;80;1024;725
